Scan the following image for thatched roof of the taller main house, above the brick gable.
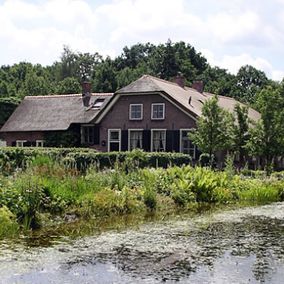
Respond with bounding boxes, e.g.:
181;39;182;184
115;75;260;121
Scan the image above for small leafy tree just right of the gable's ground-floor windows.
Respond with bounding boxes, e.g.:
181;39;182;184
189;96;233;167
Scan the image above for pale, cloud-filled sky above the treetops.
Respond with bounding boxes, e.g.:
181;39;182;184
0;0;284;81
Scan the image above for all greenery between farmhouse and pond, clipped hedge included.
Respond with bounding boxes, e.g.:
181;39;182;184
0;148;284;238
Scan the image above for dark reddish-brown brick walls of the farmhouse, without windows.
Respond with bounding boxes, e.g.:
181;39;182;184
2;94;196;152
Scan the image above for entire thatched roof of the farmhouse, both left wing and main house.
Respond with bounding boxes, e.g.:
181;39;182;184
0;75;260;132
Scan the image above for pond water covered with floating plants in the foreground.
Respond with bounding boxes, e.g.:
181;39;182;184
0;203;284;284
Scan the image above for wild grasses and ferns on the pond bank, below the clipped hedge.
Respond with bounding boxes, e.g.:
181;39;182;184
0;156;284;237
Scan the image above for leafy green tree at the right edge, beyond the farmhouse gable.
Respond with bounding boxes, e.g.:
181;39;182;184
247;87;284;175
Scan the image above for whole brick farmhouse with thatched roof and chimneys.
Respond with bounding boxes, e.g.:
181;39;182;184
0;75;260;158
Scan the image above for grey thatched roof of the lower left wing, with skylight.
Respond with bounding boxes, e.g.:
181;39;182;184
0;93;113;132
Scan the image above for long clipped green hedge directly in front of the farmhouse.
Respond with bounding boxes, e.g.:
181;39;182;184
0;147;191;171
